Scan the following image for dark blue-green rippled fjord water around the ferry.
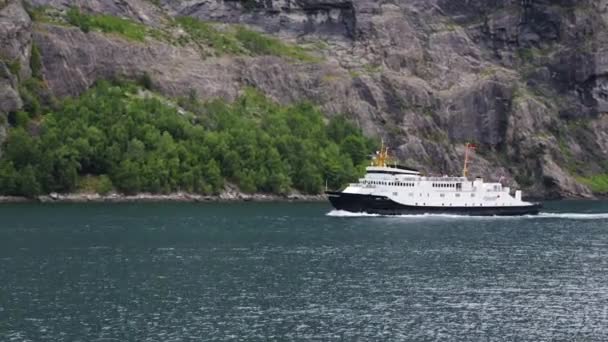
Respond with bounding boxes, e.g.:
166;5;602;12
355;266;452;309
0;202;608;341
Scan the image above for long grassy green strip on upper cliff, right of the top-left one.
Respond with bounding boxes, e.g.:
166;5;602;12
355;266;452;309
177;17;319;62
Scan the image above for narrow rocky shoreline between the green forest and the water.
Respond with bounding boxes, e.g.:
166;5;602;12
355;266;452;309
0;192;327;204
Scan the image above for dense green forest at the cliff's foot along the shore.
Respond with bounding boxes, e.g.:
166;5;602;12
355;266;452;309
0;79;377;196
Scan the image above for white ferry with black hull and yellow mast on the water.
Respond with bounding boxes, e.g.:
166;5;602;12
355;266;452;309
326;143;542;216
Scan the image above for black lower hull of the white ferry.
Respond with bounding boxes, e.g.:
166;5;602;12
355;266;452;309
326;191;542;216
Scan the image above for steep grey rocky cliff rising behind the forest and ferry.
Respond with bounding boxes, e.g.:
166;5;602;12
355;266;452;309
0;0;608;197
